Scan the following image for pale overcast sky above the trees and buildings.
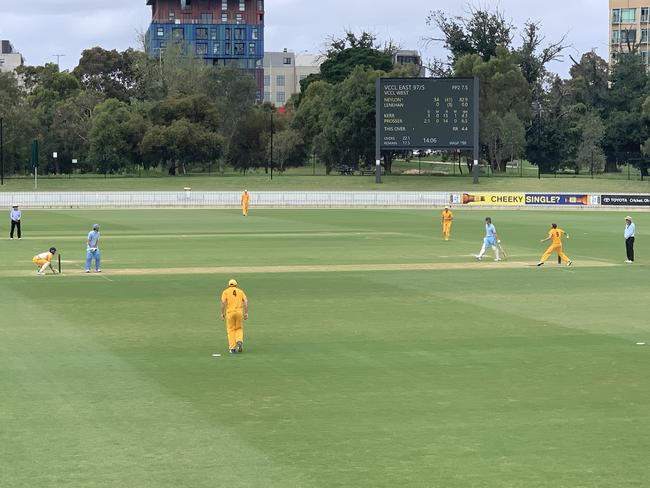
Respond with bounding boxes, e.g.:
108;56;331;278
0;0;609;76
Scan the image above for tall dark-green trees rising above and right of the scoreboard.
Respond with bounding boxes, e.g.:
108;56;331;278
427;8;650;175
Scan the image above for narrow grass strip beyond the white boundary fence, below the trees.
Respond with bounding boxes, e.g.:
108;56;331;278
0;173;650;193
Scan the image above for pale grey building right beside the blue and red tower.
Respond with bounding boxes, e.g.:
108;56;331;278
264;49;323;106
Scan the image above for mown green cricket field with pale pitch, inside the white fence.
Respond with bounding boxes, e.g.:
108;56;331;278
0;209;650;488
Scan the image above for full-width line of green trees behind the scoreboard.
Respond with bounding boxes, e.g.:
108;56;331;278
0;8;650;174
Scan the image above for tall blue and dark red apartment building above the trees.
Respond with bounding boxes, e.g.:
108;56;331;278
145;0;264;99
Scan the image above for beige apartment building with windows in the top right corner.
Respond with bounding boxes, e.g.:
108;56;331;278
609;0;650;64
